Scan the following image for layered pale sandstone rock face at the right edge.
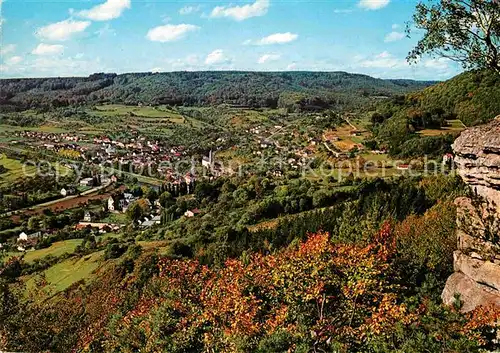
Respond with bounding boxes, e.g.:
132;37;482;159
442;116;500;312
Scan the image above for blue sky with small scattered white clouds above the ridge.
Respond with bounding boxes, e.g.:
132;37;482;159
0;0;461;80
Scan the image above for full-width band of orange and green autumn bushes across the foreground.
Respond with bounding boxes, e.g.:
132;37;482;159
0;214;500;353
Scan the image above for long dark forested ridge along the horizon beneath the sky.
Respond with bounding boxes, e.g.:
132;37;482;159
0;72;433;111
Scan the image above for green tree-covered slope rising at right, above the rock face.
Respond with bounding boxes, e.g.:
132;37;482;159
371;70;500;157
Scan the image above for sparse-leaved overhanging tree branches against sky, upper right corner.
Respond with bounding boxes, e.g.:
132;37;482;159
407;0;500;73
